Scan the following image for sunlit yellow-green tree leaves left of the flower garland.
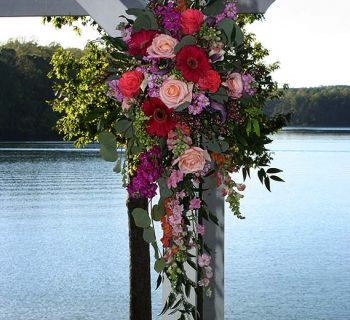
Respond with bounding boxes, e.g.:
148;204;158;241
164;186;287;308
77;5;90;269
49;43;123;145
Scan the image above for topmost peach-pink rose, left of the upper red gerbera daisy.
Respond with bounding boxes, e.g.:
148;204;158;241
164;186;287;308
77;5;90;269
147;34;179;59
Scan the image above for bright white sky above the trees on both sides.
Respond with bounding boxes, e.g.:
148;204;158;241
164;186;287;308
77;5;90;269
0;0;350;87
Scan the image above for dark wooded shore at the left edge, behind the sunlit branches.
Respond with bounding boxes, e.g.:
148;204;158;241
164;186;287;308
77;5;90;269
0;40;65;140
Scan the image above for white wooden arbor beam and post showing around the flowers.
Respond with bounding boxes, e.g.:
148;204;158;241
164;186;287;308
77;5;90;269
0;0;275;320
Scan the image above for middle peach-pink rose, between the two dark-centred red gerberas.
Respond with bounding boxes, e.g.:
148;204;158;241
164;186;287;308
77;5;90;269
159;79;193;109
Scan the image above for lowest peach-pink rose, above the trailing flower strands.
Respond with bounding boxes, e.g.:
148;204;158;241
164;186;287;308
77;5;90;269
173;147;211;174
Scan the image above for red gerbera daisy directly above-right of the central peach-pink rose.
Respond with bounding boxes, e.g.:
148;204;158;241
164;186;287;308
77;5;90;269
176;46;211;83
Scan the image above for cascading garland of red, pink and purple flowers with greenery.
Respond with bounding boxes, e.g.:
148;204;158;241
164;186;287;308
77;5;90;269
99;0;284;319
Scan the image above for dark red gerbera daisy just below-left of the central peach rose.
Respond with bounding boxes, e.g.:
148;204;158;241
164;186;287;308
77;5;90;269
142;98;176;137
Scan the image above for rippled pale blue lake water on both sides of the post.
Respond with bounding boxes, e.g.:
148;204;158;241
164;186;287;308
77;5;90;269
0;132;350;320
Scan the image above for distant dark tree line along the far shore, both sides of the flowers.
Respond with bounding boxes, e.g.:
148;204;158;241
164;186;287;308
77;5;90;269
0;40;350;141
